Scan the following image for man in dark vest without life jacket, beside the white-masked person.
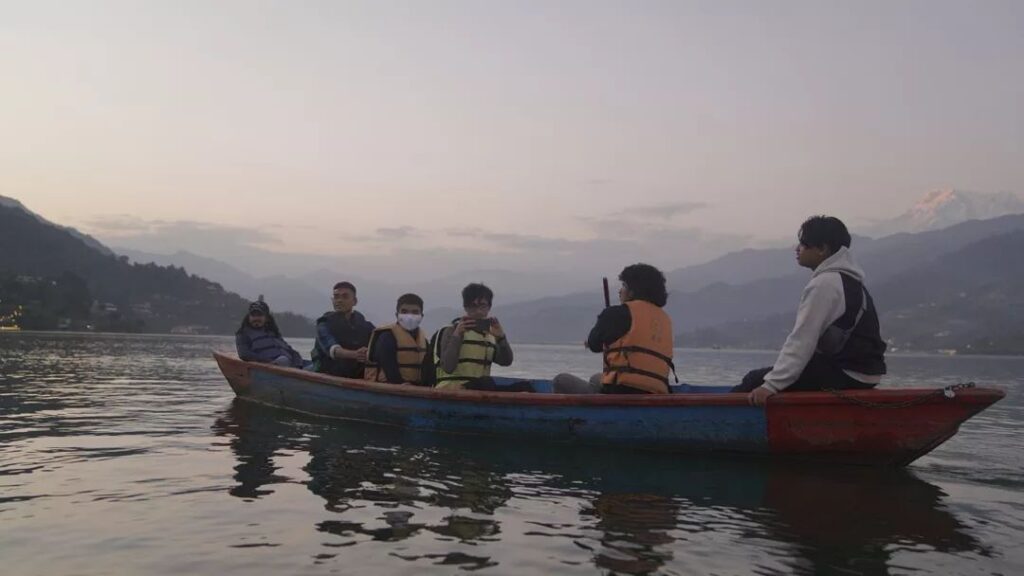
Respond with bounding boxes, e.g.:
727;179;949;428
311;282;374;378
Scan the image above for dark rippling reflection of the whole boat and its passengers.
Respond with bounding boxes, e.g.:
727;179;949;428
214;400;989;574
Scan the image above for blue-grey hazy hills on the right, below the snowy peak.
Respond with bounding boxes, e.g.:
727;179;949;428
501;214;1024;353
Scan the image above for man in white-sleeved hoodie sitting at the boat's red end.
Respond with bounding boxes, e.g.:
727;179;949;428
732;216;886;406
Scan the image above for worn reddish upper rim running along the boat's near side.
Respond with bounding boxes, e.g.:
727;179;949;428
213;351;1006;408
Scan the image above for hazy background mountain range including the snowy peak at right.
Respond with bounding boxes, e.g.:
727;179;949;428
0;191;1024;354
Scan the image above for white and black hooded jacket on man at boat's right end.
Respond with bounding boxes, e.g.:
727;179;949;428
764;247;885;393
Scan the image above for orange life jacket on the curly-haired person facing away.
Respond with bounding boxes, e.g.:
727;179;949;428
601;300;675;394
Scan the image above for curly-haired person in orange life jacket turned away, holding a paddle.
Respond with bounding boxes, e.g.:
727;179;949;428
552;263;675;394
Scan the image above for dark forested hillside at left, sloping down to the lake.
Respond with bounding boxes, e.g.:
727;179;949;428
0;202;312;336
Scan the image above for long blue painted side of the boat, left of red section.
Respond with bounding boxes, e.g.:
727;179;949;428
247;371;768;452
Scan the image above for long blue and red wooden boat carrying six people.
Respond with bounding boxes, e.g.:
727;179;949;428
213;353;1005;466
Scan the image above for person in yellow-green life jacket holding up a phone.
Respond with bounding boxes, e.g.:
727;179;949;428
430;283;534;392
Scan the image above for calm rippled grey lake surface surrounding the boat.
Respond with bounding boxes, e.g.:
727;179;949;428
0;333;1024;576
